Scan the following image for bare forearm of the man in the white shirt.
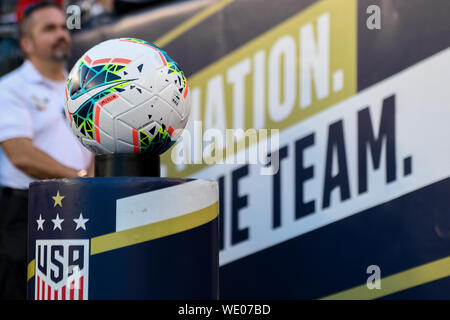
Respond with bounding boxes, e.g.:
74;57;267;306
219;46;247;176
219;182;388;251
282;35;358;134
0;138;78;179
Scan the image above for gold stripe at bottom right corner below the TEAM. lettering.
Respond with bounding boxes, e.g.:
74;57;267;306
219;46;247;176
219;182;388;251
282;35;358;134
320;257;450;300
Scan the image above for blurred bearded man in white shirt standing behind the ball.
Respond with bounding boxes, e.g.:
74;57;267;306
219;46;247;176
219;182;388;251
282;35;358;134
0;0;93;299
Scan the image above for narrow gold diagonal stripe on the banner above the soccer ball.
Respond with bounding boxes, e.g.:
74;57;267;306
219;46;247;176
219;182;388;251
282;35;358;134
154;0;234;47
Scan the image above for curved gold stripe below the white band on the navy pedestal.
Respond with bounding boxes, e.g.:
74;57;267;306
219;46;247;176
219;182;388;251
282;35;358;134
91;202;218;255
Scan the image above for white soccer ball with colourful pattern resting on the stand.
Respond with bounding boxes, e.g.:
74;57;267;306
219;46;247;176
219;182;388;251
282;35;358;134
64;38;190;154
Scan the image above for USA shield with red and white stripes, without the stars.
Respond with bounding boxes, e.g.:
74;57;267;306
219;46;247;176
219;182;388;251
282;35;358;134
35;239;89;300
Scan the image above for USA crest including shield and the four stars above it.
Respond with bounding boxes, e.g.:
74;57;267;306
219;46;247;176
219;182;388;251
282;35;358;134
30;189;90;300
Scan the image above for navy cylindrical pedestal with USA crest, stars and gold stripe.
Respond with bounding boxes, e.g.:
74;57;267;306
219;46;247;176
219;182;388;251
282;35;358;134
27;177;218;304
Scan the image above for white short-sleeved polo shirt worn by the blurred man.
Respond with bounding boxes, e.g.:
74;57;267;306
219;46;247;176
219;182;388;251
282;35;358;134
0;60;92;189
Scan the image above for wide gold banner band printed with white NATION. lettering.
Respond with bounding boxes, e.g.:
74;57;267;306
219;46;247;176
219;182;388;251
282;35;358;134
161;0;358;177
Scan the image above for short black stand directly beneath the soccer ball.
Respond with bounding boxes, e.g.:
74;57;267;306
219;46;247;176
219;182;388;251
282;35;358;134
94;152;161;177
